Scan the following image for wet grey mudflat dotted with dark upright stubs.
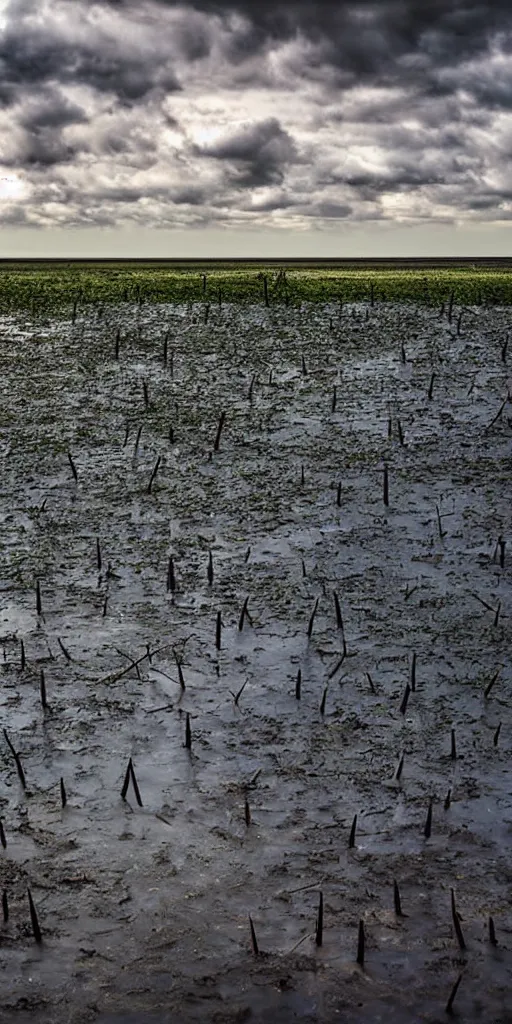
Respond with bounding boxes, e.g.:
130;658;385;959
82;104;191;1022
0;294;512;1024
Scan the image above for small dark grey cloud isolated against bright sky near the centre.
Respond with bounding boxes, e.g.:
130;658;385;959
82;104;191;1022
191;118;297;187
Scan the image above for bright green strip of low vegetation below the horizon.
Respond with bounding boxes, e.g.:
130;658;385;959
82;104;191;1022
0;264;512;314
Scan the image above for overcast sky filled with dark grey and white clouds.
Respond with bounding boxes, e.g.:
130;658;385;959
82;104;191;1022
0;0;512;258
